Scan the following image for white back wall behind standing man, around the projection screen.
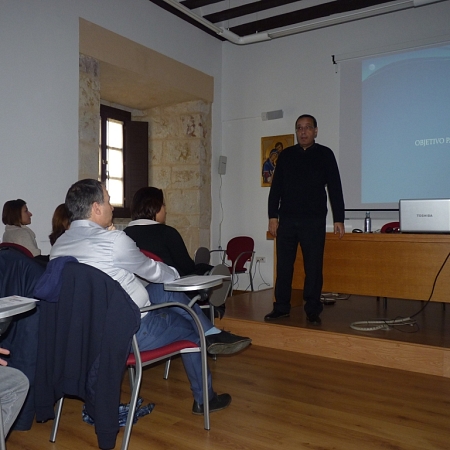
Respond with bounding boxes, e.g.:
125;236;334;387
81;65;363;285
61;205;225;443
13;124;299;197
220;1;450;288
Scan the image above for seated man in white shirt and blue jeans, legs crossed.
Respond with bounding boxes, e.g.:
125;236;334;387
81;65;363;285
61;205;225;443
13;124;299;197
50;179;251;414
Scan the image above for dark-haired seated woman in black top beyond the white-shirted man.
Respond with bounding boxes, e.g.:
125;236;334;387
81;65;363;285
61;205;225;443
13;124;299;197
124;186;212;276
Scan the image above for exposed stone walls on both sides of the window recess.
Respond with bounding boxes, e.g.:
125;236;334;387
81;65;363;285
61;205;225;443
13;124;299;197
78;54;211;256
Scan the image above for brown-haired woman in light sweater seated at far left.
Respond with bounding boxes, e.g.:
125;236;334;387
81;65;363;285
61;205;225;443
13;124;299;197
2;199;41;256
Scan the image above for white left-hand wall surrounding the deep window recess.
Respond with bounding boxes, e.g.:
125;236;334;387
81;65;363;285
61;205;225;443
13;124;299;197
0;0;222;254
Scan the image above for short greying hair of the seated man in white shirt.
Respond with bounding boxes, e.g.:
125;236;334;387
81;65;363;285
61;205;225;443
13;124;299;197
65;178;105;223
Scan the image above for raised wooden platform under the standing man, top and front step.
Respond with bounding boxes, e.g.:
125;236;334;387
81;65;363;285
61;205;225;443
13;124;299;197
220;289;450;378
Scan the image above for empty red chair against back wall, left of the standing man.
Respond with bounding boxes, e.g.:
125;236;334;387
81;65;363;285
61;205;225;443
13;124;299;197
211;236;255;295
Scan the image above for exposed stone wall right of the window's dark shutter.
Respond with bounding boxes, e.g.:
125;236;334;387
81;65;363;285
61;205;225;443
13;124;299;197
141;100;211;255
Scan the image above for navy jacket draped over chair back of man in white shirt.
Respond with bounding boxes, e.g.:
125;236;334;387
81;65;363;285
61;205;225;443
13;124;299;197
36;260;141;449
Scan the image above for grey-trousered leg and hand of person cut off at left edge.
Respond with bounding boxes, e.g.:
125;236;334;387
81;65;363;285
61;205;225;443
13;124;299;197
0;348;29;437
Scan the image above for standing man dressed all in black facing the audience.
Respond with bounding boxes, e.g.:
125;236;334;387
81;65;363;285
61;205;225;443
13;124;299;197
264;114;345;325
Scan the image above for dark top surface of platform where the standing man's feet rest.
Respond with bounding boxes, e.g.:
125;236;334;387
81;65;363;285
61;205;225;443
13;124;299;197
225;289;450;348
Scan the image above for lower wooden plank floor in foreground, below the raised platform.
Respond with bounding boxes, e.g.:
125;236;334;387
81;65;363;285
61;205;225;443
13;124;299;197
7;346;450;450
